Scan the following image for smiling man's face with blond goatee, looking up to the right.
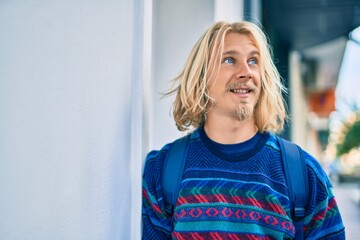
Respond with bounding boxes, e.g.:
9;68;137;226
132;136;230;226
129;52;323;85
208;33;261;121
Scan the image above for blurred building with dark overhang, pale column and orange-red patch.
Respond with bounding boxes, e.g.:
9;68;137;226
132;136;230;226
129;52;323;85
263;0;360;159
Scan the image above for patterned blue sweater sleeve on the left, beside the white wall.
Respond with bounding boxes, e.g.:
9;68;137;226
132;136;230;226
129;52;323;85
142;146;172;240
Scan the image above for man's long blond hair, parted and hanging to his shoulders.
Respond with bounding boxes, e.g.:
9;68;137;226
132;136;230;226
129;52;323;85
166;21;286;132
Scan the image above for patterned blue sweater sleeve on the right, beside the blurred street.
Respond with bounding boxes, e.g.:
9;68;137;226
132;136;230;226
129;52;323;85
303;153;345;240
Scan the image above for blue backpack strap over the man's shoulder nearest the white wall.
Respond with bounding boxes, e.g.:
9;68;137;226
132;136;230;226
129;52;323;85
161;135;189;212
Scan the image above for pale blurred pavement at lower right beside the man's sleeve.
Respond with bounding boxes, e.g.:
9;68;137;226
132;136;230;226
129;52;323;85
334;183;360;240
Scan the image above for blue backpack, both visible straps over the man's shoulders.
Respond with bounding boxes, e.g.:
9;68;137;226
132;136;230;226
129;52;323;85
162;135;309;240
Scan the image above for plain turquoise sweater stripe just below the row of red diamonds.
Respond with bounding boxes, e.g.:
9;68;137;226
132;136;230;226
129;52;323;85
173;221;295;239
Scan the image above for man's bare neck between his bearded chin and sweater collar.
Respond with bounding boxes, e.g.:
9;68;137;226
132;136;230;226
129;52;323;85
204;117;258;144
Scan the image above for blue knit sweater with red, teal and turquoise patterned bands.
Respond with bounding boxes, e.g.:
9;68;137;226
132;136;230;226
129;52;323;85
142;128;345;240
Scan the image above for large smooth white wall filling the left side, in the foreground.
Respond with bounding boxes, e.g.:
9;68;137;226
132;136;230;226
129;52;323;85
0;0;144;240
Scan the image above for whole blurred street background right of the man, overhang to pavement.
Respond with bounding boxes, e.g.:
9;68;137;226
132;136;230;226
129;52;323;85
262;0;360;240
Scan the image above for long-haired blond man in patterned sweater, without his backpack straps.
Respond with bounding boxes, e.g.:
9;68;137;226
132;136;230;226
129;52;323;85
142;22;345;240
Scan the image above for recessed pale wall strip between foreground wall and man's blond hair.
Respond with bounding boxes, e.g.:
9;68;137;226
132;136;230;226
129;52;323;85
149;0;214;149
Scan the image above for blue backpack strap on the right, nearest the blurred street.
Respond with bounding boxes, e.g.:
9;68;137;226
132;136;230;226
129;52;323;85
278;137;309;240
